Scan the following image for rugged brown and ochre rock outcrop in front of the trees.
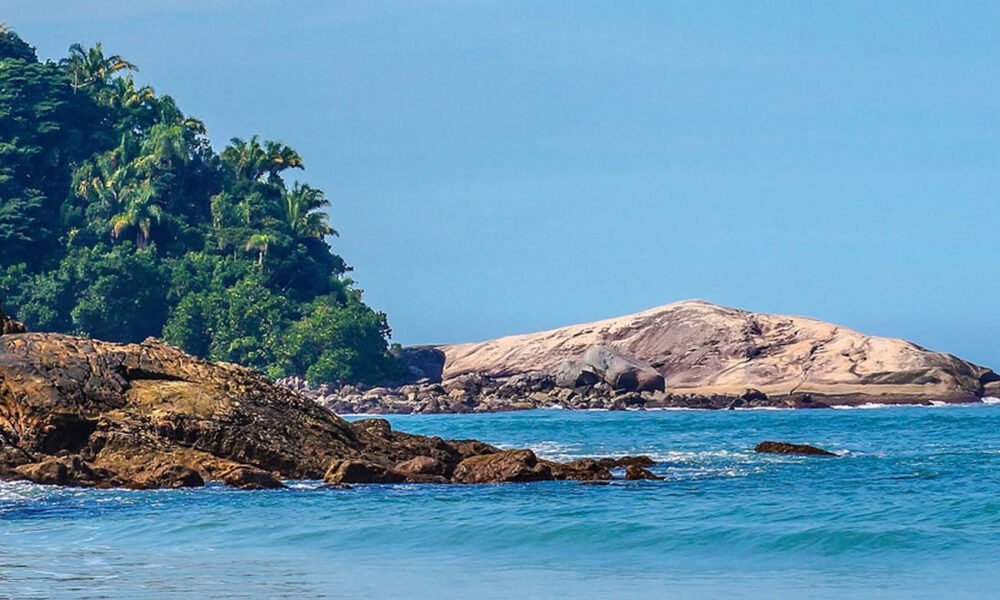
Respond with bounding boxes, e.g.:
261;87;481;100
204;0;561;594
0;333;636;489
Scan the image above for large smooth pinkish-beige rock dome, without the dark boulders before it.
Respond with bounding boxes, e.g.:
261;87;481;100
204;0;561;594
440;301;1000;404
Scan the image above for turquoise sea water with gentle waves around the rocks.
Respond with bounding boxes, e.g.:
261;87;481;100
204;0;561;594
0;405;1000;599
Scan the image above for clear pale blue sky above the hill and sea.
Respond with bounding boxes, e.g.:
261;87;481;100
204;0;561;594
0;0;1000;360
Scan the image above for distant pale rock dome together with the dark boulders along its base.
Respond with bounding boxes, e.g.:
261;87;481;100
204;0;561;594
279;301;1000;414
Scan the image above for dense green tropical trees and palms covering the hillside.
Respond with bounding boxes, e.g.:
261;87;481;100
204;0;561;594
0;27;406;382
